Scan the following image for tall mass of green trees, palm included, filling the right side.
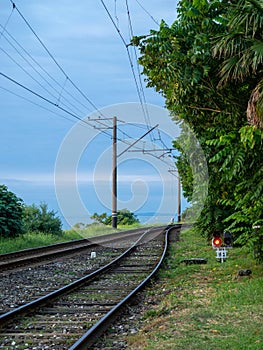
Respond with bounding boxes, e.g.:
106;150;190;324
133;0;263;260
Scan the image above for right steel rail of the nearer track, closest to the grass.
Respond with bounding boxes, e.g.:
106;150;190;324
69;225;176;350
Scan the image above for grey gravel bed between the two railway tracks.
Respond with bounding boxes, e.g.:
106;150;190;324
0;246;123;314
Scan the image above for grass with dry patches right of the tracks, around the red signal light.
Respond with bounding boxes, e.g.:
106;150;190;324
128;230;263;350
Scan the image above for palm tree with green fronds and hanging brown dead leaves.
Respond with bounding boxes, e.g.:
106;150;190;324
214;0;263;129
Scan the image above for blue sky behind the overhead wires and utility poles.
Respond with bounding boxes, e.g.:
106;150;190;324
0;0;185;227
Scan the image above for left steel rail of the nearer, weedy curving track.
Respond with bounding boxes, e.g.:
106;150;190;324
0;228;160;328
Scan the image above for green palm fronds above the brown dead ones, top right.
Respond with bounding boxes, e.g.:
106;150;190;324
214;0;263;84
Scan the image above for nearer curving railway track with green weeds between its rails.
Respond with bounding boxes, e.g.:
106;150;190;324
0;225;179;350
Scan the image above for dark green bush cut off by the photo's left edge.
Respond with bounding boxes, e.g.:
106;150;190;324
0;185;23;237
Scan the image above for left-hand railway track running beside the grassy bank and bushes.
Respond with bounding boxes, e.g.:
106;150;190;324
0;228;163;273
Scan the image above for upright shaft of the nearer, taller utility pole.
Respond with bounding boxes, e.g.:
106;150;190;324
111;117;117;228
